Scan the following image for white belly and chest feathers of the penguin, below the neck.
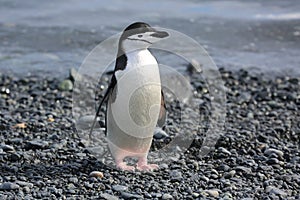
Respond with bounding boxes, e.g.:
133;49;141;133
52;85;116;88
107;49;161;153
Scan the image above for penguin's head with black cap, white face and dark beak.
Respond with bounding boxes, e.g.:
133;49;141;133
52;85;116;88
120;22;169;51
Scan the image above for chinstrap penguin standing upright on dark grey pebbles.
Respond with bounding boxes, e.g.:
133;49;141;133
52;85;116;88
90;22;169;171
